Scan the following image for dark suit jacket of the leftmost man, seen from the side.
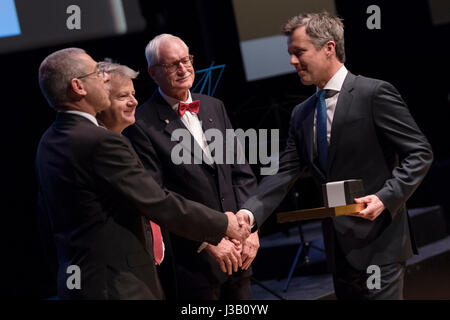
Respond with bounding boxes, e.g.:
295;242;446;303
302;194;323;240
36;113;227;299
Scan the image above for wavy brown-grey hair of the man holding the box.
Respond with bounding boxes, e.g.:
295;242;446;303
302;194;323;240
282;12;345;63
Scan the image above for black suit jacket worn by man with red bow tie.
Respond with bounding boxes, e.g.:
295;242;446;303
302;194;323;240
124;91;256;292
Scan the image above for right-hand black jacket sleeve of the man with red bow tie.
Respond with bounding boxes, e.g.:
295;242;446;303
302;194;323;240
220;103;257;208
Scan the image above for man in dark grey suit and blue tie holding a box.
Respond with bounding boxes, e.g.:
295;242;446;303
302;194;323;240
238;13;432;299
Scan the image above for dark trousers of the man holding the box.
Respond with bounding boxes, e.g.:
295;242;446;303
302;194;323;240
333;255;406;300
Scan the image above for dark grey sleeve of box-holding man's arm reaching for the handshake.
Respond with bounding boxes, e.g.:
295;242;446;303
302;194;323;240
242;107;310;228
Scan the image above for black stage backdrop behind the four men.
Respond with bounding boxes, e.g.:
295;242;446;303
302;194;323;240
0;0;450;298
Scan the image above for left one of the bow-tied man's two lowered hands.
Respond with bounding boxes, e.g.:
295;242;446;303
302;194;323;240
205;237;242;275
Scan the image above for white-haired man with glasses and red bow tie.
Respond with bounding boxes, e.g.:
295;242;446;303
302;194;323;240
124;34;259;299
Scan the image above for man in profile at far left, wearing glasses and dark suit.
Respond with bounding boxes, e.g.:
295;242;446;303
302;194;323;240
36;48;250;299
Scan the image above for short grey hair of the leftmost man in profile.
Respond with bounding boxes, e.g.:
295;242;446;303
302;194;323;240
39;48;86;108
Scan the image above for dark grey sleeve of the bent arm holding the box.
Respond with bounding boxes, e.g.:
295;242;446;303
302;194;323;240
372;82;433;216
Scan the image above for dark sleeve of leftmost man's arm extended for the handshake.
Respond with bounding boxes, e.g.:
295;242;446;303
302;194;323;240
93;135;228;244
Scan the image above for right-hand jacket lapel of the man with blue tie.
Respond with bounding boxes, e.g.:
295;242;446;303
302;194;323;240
327;72;356;172
